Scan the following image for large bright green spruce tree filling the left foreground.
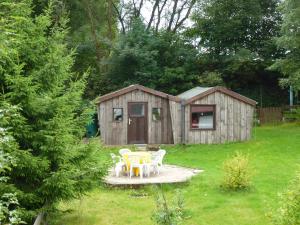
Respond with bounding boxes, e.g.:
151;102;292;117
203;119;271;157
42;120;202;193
0;0;103;221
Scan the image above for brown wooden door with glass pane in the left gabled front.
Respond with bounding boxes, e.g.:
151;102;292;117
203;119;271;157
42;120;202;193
127;102;148;144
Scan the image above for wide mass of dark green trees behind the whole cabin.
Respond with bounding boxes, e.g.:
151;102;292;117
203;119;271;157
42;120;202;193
27;0;290;106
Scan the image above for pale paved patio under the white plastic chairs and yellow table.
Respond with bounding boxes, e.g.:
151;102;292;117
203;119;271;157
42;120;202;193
104;165;203;186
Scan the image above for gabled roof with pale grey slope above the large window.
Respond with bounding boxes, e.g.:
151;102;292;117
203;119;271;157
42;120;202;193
177;86;257;106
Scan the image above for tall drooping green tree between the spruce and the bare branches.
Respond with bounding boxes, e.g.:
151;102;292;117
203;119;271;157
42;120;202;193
33;0;118;99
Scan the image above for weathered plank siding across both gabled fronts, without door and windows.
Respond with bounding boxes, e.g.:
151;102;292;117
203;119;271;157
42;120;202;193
97;86;255;145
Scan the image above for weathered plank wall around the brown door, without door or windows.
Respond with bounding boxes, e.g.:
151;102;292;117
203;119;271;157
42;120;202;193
98;90;174;145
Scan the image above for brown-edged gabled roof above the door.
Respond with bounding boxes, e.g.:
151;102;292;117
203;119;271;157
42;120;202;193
96;84;180;104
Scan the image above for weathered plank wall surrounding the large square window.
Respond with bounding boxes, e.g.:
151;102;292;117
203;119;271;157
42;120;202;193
185;91;254;144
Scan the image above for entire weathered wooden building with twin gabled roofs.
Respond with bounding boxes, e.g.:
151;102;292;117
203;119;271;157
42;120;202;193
96;85;256;145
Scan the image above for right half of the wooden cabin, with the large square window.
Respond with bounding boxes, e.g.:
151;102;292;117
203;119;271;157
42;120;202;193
178;87;256;144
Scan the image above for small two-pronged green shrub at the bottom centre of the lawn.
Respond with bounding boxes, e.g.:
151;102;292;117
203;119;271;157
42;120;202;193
152;188;186;225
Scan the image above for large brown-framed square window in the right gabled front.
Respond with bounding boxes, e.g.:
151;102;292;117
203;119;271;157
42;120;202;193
191;105;216;130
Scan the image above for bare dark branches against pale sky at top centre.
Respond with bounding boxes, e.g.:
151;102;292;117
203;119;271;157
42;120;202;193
113;0;196;34
